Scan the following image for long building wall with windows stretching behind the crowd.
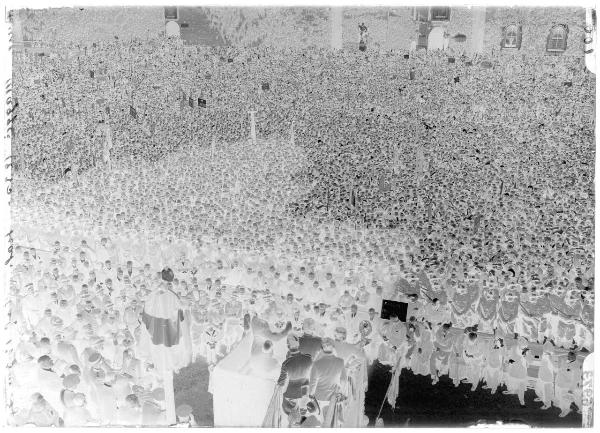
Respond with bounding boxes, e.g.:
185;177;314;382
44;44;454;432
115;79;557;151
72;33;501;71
13;7;595;62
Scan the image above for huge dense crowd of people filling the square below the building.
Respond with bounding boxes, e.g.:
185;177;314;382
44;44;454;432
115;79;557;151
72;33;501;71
5;26;594;425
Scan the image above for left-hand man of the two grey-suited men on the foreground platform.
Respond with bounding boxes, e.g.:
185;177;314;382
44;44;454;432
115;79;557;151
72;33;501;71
277;335;312;415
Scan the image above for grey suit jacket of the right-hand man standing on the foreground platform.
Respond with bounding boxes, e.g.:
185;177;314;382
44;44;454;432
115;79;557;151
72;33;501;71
310;353;346;401
